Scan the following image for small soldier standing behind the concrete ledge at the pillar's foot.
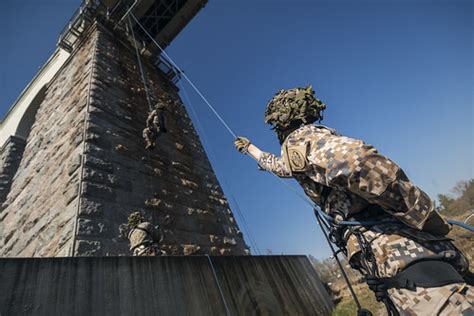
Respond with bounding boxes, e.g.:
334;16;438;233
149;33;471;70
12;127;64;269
127;212;165;256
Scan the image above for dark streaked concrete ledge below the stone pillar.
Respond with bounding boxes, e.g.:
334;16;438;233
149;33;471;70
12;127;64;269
0;256;333;316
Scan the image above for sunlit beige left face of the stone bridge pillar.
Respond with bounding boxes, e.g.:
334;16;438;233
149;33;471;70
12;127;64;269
0;27;95;256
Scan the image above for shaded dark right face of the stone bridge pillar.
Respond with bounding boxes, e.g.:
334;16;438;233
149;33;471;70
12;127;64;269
76;24;246;255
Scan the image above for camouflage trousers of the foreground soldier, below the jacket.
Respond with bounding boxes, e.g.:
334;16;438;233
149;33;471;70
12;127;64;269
347;224;474;315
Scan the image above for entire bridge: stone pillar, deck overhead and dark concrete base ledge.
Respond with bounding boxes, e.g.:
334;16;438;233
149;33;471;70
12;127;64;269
0;0;333;315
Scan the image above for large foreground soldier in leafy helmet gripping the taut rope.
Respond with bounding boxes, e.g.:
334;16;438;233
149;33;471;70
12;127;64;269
235;86;474;315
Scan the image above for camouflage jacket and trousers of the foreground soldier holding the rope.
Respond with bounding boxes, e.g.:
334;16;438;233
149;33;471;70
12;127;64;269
259;125;474;315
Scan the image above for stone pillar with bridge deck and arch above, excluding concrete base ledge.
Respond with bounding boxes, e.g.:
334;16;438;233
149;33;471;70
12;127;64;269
0;0;248;257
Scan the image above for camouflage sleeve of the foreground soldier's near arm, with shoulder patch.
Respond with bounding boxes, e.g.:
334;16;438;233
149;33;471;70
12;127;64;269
287;125;446;229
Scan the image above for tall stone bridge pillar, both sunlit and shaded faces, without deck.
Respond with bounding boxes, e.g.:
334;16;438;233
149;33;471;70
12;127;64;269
0;25;247;256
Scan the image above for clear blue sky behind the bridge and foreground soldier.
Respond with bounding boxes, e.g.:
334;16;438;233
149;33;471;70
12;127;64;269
0;0;474;257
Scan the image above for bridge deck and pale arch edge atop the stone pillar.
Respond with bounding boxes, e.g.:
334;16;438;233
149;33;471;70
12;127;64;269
0;0;207;148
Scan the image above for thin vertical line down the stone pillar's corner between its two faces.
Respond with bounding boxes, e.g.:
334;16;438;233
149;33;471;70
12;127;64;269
70;31;100;257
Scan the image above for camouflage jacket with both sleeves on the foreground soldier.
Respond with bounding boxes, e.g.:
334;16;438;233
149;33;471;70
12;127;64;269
259;125;447;229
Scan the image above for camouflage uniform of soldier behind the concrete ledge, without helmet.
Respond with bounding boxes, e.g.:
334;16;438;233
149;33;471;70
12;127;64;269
128;222;160;256
